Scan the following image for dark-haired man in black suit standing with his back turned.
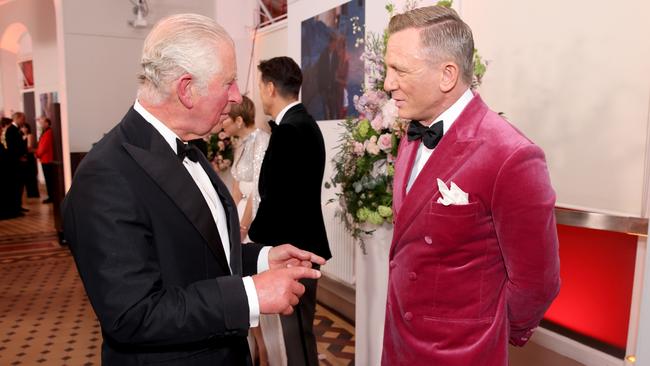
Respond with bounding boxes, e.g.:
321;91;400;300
248;57;332;366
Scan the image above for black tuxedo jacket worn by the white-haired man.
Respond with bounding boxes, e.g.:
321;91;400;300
63;109;261;366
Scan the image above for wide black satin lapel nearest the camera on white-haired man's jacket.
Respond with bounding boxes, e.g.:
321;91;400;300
123;137;230;273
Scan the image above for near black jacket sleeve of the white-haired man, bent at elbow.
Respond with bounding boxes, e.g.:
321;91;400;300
63;159;249;346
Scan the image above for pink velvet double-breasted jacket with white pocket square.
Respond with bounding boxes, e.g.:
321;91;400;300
382;94;560;366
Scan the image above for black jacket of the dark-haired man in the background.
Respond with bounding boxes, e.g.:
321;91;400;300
248;104;332;259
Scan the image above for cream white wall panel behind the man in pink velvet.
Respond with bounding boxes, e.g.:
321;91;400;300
461;0;650;216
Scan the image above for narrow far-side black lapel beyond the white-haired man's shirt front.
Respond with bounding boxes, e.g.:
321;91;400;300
199;154;243;274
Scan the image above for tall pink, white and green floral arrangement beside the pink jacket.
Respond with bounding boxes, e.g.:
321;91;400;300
325;0;487;252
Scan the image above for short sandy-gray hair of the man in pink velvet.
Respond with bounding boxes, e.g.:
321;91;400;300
388;5;474;85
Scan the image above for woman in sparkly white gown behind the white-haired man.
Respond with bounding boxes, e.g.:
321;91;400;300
223;96;287;366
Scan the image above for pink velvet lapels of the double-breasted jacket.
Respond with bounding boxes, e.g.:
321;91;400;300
391;94;488;255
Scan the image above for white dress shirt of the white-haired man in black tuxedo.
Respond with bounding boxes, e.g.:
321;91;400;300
133;100;271;327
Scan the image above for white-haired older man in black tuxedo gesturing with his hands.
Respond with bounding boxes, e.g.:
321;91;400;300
63;14;324;366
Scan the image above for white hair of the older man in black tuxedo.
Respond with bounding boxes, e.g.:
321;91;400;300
138;14;234;103
